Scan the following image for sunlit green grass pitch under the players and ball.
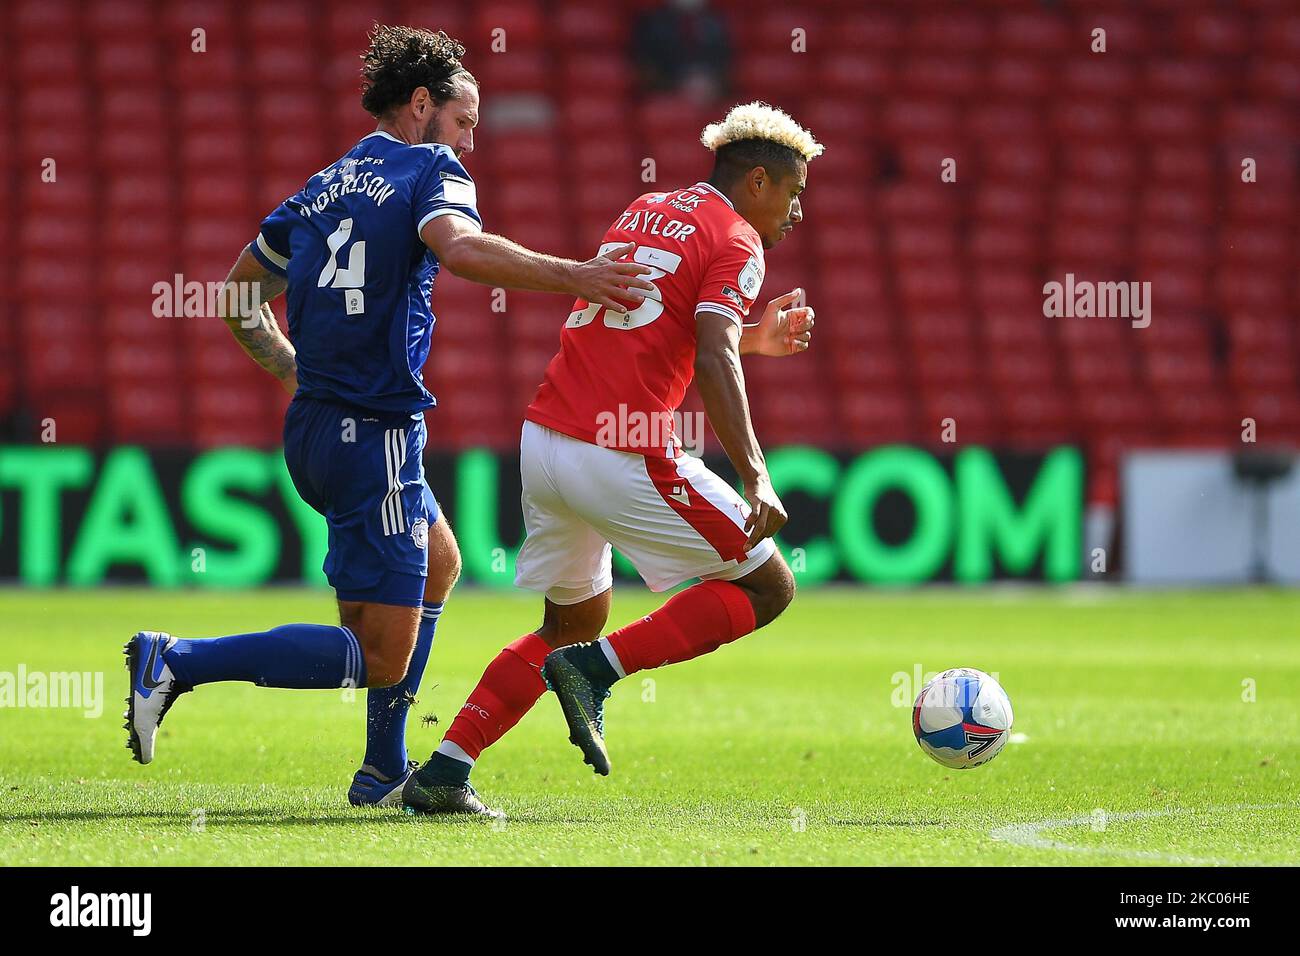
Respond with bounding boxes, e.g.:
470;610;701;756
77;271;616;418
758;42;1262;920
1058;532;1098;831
0;588;1300;865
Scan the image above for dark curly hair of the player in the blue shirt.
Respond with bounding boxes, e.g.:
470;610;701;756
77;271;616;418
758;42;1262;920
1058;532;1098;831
361;23;478;117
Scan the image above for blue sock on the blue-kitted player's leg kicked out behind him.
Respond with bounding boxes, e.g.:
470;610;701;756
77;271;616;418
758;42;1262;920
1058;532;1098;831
163;624;365;688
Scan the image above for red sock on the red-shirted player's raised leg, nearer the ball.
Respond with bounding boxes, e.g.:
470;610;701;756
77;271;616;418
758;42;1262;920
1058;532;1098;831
608;581;755;674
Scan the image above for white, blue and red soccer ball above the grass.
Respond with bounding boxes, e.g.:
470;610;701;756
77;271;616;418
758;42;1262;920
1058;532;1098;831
911;667;1011;770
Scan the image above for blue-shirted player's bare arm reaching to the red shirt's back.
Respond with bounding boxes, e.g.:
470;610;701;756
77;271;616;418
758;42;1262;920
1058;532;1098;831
420;216;654;312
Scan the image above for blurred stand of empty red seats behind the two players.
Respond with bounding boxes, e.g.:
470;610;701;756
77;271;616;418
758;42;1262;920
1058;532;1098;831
0;0;1300;470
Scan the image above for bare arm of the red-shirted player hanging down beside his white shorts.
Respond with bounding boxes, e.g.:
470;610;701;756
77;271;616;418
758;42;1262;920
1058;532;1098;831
696;312;787;550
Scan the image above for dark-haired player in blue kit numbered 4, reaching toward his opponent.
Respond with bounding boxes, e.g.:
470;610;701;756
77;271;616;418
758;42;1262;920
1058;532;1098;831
126;26;654;813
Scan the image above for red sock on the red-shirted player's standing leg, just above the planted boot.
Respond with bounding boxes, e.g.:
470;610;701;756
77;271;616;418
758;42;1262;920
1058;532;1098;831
443;633;551;760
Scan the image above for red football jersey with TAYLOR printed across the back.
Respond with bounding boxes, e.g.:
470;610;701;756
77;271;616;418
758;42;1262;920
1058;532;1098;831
525;182;764;458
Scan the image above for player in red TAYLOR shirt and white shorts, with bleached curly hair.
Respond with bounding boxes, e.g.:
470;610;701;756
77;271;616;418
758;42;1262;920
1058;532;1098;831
403;103;822;816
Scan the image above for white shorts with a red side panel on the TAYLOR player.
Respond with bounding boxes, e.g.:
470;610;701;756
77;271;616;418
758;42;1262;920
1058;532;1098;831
515;421;776;605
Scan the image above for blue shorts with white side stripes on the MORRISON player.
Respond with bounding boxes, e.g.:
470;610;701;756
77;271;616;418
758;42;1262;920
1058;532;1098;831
285;398;438;607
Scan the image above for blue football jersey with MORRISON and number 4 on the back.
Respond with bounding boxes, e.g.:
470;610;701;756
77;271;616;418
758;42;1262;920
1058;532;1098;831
251;131;482;414
